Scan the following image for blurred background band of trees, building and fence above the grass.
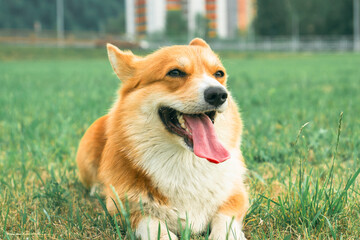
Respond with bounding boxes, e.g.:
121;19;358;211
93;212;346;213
0;0;360;51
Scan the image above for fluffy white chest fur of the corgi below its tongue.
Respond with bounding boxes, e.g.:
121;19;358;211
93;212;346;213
139;147;244;232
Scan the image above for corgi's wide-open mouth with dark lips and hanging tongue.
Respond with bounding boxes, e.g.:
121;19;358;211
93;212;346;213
159;107;230;163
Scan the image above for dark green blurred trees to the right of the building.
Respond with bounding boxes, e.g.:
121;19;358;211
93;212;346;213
254;0;353;36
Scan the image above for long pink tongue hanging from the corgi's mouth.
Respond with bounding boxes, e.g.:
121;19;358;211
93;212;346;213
184;114;230;163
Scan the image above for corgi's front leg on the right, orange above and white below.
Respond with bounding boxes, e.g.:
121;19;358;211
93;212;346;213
209;186;249;240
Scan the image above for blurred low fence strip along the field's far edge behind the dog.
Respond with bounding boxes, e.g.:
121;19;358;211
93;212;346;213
0;30;360;51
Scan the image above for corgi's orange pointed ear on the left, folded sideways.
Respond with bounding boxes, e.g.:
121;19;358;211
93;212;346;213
106;43;138;81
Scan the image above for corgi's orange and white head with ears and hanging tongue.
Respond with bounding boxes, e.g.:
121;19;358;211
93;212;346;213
107;38;230;163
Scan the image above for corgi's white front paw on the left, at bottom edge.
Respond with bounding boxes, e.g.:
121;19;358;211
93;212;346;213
136;217;178;240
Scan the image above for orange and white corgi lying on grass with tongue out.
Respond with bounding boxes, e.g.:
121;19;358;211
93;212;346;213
77;38;249;240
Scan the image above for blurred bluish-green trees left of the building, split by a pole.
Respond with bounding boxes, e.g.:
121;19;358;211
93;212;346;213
0;0;125;32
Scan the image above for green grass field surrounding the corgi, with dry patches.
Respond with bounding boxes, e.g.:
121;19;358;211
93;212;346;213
0;47;360;239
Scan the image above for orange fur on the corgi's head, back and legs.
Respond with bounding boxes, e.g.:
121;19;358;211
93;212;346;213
77;39;248;238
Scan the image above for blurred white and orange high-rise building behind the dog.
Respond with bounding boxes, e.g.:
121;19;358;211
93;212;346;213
126;0;254;39
